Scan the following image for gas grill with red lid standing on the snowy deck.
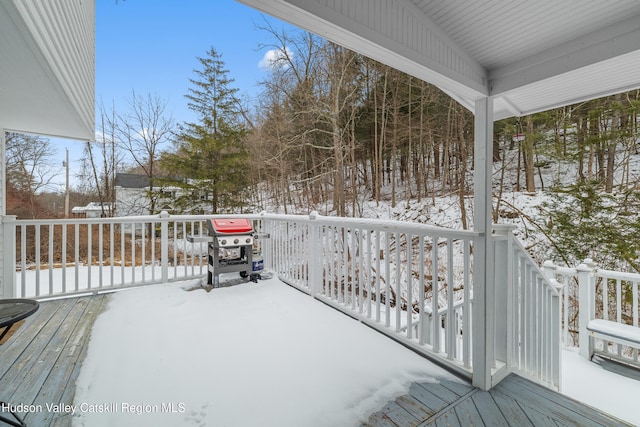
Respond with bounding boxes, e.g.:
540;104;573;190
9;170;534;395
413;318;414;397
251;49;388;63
188;218;269;288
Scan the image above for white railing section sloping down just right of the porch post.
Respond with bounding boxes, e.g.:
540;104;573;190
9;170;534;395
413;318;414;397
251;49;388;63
494;224;562;389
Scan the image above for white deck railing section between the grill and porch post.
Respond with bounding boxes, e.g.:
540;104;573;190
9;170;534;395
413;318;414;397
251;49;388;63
263;213;478;375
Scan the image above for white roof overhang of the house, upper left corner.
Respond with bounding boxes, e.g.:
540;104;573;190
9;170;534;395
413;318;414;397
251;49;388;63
0;0;95;140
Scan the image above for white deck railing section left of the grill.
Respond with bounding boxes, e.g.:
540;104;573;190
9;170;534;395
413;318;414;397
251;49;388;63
4;213;260;298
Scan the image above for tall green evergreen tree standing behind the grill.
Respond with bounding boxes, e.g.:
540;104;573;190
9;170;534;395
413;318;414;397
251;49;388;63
163;48;248;214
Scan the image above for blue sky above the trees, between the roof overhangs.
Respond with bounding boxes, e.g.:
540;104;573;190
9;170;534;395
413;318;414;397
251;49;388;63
51;0;293;191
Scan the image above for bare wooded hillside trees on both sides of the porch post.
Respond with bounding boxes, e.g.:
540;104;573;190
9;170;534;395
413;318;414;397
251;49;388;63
249;32;640;221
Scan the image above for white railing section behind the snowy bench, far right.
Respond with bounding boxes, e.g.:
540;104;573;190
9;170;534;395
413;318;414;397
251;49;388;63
544;259;640;366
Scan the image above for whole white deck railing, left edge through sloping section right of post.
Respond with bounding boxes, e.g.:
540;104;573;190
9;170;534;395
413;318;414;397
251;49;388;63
2;213;560;388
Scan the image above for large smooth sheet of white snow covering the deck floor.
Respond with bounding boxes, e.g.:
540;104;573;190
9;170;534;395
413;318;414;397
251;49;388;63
73;279;460;427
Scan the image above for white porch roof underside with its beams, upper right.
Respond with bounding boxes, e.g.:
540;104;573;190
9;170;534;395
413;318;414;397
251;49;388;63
239;0;640;119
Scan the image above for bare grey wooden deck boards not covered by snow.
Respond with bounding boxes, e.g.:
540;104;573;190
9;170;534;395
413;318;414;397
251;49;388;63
0;295;625;426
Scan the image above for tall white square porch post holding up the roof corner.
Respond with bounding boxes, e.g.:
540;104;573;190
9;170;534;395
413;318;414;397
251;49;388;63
472;97;496;390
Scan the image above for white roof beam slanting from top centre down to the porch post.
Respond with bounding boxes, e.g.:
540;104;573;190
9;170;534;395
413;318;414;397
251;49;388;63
238;0;488;101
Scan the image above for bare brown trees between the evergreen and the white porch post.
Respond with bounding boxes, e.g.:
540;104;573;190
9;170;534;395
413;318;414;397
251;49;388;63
249;29;473;216
